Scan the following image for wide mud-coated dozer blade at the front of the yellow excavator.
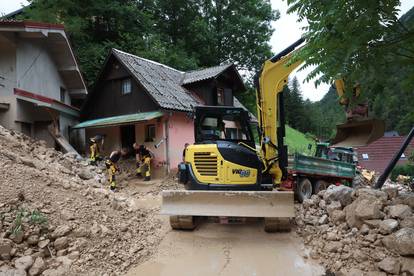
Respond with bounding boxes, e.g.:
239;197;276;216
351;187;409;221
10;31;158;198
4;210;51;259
161;190;295;218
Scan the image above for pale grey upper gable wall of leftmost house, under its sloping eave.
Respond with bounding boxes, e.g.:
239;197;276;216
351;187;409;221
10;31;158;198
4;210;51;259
16;38;66;101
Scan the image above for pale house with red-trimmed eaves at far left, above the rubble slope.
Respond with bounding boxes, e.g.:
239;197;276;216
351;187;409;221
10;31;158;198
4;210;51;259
0;20;87;149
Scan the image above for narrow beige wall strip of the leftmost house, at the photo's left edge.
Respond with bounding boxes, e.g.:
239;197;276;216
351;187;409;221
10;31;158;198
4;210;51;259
0;33;20;131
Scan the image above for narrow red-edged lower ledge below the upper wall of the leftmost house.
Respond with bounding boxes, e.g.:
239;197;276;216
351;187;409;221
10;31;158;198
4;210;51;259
14;88;80;118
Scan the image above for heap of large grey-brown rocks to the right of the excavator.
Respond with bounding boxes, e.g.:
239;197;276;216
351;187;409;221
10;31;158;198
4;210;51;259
296;186;414;275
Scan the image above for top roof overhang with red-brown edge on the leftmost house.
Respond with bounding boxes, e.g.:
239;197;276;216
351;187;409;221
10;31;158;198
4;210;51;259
0;20;88;98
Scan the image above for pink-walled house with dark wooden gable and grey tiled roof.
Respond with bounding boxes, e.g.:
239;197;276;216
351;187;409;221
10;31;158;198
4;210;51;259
74;49;245;173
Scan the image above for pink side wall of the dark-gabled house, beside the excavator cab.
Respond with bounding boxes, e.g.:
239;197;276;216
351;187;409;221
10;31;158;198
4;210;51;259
168;112;194;170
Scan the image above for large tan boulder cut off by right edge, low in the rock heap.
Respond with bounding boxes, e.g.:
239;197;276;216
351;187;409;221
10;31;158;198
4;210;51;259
382;228;414;256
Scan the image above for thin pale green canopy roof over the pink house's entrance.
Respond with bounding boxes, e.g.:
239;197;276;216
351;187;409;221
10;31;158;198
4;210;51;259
72;111;164;129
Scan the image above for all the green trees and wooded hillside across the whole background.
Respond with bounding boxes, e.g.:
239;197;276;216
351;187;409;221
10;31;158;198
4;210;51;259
21;0;414;139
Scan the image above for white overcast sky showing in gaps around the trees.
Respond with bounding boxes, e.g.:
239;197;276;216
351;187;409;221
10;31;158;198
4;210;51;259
0;0;414;101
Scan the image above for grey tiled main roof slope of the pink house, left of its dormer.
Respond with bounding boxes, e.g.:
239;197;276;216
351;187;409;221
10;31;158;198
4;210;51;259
112;49;200;111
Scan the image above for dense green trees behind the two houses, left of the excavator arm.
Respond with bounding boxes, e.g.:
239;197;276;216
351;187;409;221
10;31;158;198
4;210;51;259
23;0;279;85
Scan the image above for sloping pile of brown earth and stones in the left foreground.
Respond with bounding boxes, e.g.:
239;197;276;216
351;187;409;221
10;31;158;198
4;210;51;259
0;126;165;276
